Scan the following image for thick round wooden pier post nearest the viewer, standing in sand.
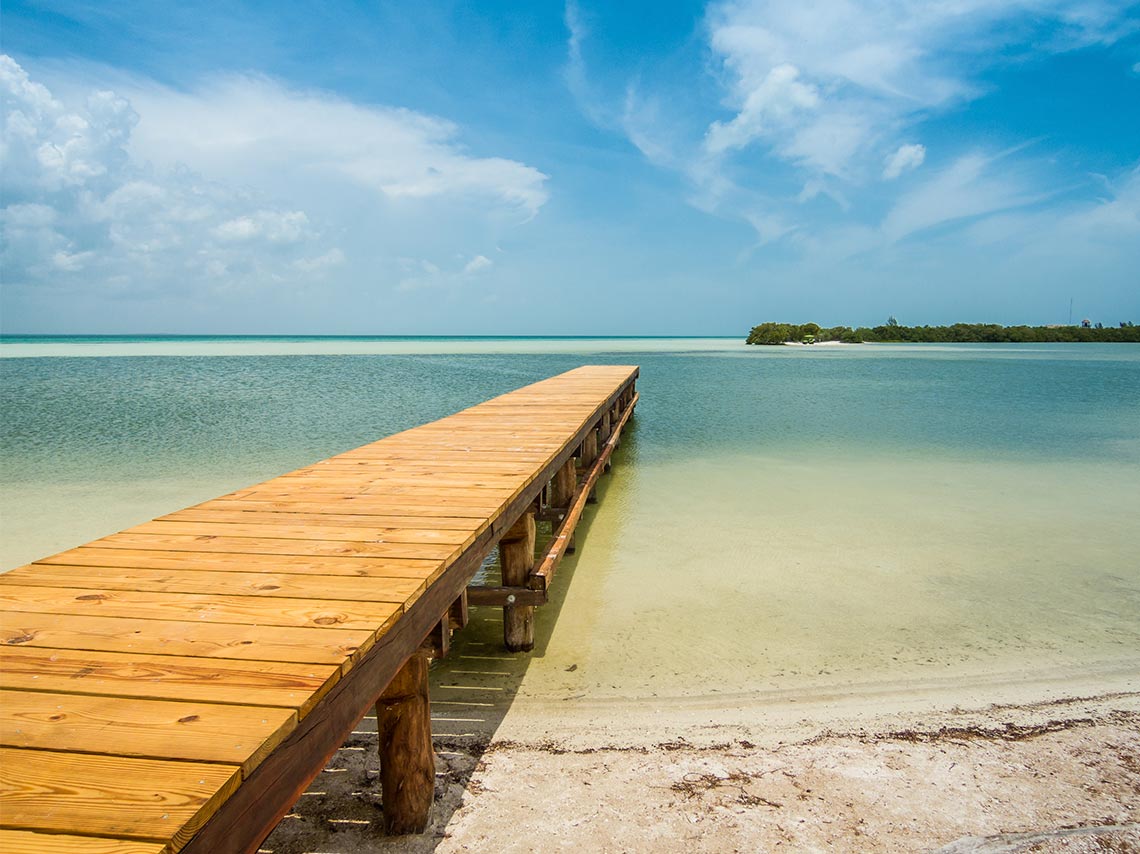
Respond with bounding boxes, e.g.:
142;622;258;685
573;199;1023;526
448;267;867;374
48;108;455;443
376;652;435;836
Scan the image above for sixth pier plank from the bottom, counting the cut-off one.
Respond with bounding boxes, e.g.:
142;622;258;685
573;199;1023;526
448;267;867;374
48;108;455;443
0;583;412;631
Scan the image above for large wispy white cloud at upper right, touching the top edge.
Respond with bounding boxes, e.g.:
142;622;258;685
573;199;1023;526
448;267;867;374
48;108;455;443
665;0;1140;245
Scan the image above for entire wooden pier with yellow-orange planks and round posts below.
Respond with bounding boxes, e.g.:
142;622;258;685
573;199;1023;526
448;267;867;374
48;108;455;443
0;366;637;854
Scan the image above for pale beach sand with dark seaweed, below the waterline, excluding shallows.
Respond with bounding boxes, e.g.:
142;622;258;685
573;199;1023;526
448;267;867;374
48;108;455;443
262;693;1140;854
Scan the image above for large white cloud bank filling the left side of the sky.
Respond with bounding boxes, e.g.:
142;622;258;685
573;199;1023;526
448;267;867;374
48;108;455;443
0;55;547;325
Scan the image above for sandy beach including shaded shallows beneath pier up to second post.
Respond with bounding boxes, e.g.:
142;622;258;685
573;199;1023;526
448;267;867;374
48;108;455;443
262;592;1140;854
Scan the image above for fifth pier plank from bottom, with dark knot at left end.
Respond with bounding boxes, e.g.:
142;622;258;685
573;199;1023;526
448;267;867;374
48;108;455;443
0;612;373;665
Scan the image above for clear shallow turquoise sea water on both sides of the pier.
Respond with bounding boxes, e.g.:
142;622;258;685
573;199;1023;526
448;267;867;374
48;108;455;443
0;339;1140;699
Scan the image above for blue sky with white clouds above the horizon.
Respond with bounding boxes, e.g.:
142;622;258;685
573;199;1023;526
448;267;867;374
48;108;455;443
0;0;1140;335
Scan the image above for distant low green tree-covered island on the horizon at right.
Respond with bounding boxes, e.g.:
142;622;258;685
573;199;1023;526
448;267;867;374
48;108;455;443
748;317;1140;344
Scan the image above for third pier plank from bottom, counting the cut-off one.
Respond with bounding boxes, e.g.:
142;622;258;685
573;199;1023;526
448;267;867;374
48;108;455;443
0;691;298;774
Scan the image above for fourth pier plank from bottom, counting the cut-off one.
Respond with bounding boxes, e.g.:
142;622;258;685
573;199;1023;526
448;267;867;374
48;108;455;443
0;645;341;717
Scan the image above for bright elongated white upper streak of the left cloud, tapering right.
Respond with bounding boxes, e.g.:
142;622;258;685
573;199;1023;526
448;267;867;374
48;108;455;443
122;76;548;219
